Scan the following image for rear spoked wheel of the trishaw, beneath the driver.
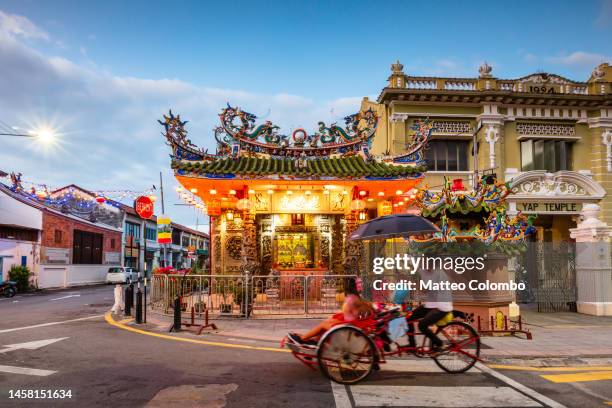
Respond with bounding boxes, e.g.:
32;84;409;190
430;322;480;374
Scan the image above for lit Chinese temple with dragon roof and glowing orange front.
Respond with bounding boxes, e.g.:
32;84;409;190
159;105;432;275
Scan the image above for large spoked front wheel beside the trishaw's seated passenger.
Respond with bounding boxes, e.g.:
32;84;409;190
317;326;377;384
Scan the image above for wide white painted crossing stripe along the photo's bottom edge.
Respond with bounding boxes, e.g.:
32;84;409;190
351;385;542;407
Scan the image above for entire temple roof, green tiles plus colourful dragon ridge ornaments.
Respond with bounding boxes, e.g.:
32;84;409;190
159;105;433;181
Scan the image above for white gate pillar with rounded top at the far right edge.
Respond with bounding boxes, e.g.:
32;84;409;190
570;204;612;316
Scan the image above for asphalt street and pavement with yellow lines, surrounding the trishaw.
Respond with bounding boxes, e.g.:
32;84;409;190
0;286;612;407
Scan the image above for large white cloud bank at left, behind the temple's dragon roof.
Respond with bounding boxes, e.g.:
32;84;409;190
0;9;361;224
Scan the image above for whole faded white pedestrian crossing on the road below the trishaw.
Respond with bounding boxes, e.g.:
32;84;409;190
332;359;563;408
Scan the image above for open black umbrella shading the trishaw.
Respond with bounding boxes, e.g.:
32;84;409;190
349;214;440;240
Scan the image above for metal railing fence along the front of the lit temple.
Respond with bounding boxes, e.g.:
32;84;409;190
150;274;357;317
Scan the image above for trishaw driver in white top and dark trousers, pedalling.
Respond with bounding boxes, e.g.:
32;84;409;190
408;269;453;351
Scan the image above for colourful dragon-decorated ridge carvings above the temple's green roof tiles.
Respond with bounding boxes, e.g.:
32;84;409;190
158;104;431;164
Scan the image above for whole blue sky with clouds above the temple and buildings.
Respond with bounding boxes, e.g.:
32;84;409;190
0;0;612;225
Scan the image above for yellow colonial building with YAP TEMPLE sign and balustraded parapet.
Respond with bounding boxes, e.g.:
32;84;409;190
362;61;612;241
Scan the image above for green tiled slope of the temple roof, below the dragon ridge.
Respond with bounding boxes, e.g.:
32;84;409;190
172;155;426;178
